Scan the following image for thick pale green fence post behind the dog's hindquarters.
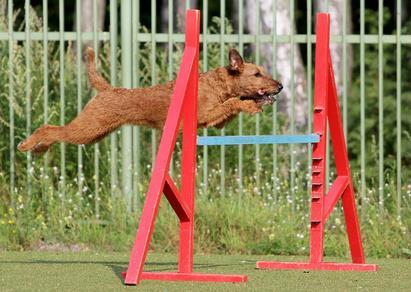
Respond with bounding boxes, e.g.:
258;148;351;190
121;0;133;212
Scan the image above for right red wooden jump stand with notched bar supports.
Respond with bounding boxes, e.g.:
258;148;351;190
257;13;378;271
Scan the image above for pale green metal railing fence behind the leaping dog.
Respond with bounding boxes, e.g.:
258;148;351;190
0;0;411;218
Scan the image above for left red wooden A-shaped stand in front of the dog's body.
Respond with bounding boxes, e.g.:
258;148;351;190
123;10;247;285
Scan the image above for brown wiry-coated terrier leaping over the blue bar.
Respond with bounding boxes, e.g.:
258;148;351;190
18;48;283;153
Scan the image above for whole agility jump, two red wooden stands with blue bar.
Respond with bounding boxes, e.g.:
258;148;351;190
123;10;378;285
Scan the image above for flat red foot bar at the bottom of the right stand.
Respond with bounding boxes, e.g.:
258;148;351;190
257;261;378;272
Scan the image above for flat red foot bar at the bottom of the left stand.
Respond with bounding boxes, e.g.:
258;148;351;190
121;272;248;285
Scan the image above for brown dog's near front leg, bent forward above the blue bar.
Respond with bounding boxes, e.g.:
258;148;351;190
205;98;261;128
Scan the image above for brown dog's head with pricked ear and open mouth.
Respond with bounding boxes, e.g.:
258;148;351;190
227;49;283;105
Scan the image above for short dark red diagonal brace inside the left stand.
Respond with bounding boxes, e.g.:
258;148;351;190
163;174;192;221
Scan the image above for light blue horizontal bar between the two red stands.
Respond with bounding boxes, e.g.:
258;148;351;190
197;134;320;146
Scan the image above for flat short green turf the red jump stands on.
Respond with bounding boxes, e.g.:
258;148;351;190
0;252;411;291
